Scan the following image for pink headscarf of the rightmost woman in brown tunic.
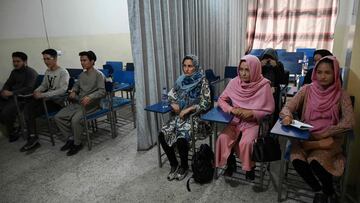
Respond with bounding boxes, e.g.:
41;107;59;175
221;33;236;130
304;56;341;133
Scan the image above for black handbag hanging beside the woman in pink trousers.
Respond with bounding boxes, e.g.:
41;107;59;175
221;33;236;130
252;136;281;162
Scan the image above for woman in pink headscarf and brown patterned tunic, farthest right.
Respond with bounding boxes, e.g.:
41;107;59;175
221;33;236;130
280;56;353;202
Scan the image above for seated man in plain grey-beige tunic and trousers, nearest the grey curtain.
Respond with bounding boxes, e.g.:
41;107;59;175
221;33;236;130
55;51;105;156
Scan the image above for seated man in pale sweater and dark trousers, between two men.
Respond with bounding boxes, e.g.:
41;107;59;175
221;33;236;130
20;49;69;152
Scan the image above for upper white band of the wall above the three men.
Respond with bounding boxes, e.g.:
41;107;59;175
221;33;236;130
0;0;130;39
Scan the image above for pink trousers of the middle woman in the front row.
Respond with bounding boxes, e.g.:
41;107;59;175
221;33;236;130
215;124;259;171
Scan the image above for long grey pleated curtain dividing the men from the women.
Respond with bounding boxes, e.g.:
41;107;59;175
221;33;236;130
128;0;248;150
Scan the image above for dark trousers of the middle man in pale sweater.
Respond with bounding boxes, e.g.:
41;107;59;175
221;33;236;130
24;99;62;135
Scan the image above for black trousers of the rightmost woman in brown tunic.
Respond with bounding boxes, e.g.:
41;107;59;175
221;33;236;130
292;159;335;195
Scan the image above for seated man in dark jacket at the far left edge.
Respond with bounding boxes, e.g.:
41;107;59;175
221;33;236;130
0;52;38;142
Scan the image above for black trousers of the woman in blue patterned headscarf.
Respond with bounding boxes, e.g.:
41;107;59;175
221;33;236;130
159;133;189;169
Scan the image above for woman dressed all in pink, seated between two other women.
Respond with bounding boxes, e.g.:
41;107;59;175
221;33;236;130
215;55;275;180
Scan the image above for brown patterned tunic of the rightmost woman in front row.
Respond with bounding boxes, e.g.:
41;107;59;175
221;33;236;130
280;86;354;176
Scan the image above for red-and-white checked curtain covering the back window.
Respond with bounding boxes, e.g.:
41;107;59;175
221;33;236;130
247;0;339;51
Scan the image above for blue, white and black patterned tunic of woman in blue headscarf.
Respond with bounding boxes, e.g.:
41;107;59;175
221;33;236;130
161;77;211;146
